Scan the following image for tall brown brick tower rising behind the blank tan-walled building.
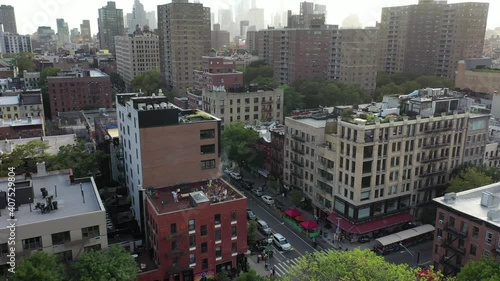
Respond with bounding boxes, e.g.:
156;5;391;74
158;0;211;95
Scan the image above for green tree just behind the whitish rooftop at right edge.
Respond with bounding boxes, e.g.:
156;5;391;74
446;167;493;192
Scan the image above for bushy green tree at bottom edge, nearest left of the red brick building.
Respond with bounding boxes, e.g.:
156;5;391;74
70;246;138;281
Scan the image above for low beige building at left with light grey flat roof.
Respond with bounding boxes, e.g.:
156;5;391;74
0;162;108;274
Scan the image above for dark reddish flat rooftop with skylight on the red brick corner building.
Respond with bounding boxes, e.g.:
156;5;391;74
146;178;245;214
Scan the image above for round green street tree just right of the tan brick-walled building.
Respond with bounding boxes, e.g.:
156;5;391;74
222;122;259;165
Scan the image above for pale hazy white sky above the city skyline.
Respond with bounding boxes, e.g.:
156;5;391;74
2;0;500;34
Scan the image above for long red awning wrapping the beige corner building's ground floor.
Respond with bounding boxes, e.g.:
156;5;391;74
328;213;413;234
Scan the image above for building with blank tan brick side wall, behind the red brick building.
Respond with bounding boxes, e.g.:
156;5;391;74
116;93;221;231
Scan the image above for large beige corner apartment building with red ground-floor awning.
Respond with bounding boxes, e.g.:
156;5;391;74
284;89;489;239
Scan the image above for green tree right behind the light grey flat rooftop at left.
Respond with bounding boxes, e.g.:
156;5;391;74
50;141;106;178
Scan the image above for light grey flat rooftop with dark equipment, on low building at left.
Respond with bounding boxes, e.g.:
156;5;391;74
0;167;104;229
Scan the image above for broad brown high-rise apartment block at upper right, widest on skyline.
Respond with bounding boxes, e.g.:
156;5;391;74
378;0;489;79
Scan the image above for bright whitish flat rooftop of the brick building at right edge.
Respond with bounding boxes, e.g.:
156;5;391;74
433;182;500;227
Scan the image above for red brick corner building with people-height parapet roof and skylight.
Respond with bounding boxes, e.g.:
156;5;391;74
139;179;247;281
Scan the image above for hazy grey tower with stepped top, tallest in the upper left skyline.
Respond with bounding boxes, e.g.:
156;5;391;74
97;1;125;53
